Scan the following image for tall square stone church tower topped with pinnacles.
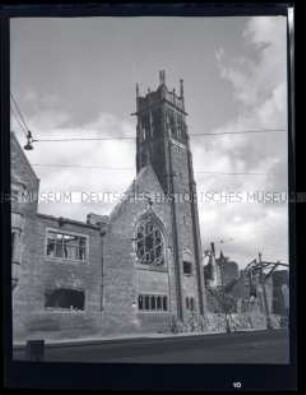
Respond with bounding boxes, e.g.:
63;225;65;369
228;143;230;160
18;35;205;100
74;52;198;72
135;70;204;321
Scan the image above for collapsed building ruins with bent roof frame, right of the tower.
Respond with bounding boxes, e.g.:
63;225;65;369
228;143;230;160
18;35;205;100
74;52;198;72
204;243;289;316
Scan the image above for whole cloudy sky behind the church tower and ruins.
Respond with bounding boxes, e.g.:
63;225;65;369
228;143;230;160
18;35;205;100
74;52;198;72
11;16;288;267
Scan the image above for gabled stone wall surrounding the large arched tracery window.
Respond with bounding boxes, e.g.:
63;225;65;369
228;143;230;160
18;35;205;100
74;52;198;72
103;167;176;334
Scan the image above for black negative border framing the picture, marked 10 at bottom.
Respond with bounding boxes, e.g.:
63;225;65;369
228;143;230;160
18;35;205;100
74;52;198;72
0;2;297;391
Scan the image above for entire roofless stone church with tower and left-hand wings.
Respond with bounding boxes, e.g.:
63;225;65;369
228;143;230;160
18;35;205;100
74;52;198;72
11;71;205;339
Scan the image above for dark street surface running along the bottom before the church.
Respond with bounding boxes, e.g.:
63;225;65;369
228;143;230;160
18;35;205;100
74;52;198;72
13;330;289;364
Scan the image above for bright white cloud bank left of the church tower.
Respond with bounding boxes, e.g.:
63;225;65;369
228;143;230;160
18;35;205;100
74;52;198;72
14;111;136;220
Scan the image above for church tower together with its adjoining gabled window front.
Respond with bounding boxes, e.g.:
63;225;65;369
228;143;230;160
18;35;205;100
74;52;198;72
102;71;205;334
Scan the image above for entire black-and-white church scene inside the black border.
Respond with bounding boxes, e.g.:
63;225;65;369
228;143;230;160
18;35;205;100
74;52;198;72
10;15;292;365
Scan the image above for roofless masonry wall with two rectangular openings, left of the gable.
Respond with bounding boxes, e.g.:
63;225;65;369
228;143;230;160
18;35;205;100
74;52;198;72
13;214;102;341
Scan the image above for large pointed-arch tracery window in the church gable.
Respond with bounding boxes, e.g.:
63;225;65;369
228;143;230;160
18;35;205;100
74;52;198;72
136;216;164;266
